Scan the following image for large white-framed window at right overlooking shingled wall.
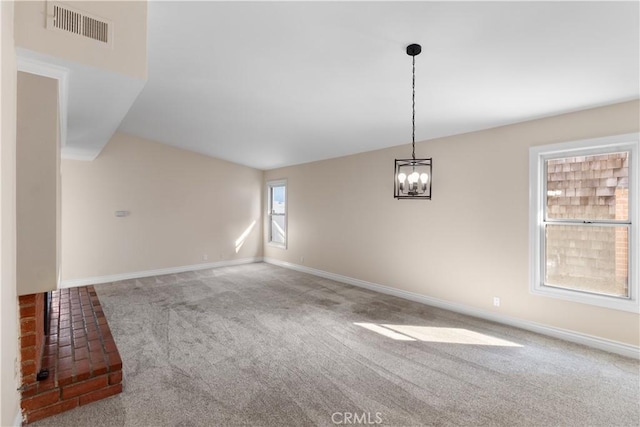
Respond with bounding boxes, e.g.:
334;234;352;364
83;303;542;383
530;134;640;312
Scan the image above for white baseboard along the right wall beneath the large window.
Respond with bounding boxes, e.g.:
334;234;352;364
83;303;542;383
263;257;640;359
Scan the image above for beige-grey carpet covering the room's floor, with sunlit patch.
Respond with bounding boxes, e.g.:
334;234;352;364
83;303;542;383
34;263;640;426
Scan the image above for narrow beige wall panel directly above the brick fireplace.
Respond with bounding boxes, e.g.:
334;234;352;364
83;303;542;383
16;72;60;295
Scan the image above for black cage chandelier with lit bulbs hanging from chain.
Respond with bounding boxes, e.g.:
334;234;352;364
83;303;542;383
393;44;433;200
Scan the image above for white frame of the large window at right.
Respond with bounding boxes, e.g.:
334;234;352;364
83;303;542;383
529;133;640;313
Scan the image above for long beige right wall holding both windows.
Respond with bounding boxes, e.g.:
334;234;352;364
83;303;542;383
264;101;640;346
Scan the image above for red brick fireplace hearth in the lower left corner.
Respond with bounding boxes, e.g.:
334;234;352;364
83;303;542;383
19;286;122;423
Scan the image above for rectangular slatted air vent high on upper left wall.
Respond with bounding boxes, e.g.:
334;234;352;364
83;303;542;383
47;2;113;47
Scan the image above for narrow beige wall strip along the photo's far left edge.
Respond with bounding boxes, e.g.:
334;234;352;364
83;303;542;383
0;1;20;426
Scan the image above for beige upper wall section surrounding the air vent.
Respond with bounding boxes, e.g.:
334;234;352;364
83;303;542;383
15;1;147;79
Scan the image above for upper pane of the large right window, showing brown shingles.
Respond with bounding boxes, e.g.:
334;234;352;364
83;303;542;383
546;152;629;221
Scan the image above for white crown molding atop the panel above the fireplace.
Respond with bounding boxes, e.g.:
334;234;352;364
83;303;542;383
16;48;69;149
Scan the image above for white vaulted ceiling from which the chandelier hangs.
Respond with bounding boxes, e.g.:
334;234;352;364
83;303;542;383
120;2;640;169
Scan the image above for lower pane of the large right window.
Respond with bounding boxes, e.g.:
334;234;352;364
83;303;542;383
544;224;629;297
